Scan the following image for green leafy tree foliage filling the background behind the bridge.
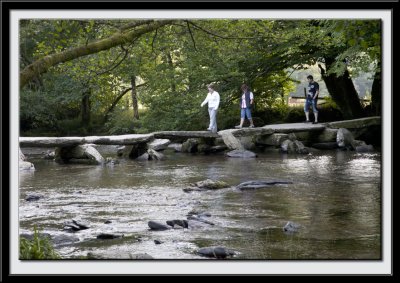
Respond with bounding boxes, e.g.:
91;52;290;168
20;19;381;135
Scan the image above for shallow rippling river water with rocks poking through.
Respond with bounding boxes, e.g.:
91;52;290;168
19;149;382;259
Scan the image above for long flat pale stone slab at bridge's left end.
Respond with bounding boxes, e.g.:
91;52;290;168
19;134;153;147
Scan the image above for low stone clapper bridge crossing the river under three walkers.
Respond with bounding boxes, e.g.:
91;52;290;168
19;117;381;168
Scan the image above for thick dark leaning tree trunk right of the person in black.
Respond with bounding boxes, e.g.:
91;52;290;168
318;58;364;119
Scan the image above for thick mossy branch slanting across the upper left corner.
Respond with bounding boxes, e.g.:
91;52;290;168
19;20;174;89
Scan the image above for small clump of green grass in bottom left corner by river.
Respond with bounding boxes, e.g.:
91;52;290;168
19;226;61;259
